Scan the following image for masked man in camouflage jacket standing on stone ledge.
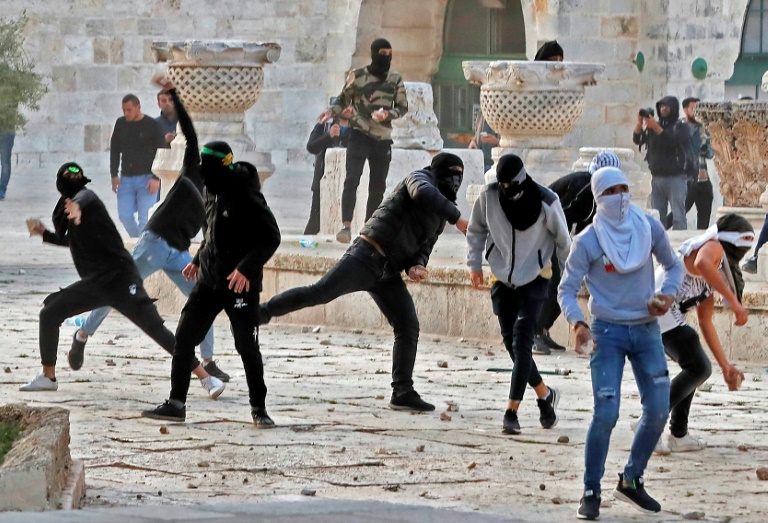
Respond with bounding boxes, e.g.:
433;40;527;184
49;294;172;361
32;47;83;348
318;38;408;243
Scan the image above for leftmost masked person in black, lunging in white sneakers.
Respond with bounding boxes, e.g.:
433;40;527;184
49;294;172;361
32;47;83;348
19;162;214;392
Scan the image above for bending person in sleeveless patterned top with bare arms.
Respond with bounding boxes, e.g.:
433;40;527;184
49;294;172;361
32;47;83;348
654;214;755;454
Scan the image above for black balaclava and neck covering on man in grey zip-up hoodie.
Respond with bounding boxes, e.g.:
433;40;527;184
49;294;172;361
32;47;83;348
496;154;541;231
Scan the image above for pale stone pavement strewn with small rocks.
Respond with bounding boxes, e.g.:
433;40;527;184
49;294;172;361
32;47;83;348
0;172;768;522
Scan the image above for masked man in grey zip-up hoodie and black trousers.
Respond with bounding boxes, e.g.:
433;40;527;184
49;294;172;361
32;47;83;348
467;154;571;434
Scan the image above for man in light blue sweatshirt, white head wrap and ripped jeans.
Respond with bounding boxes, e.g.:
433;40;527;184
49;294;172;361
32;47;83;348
558;167;683;520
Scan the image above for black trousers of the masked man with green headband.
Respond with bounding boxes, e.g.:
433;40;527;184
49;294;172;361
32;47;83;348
171;282;267;408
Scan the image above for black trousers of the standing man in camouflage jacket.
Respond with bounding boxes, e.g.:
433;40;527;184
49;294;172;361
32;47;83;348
341;129;392;222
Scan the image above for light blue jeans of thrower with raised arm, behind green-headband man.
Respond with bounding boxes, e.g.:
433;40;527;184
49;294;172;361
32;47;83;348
80;231;213;360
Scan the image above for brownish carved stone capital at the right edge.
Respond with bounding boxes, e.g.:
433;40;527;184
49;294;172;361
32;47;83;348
695;101;768;231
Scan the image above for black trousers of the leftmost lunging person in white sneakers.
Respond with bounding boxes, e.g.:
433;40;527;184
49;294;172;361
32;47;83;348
40;271;188;368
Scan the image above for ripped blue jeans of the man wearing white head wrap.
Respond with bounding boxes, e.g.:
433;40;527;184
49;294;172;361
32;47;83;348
584;320;670;493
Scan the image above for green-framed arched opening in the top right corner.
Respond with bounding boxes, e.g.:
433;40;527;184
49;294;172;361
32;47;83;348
725;0;768;100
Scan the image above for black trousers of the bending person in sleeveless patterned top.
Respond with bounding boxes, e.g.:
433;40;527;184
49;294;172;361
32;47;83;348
661;325;712;438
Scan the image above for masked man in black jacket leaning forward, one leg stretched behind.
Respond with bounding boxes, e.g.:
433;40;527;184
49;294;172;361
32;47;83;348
259;153;467;411
